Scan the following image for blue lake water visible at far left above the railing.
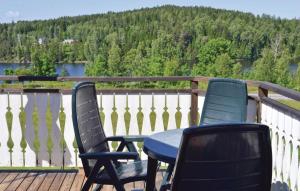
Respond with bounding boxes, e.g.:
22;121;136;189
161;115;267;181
0;63;84;76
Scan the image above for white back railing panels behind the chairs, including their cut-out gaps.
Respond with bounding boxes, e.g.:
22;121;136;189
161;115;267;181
0;93;256;167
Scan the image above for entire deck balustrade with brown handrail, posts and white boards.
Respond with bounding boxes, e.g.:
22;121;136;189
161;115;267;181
0;76;300;190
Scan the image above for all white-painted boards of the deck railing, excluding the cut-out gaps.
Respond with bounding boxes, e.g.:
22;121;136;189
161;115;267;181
7;90;300;189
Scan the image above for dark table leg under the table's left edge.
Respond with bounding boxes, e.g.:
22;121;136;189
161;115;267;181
146;156;158;191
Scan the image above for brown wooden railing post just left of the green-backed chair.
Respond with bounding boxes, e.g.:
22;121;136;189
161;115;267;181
191;80;198;126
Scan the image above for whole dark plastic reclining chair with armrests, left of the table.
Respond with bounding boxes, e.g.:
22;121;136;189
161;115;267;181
72;82;147;191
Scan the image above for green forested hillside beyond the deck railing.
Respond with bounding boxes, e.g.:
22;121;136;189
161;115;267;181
0;6;300;90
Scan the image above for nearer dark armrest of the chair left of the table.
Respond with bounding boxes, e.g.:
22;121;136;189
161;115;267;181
79;152;139;160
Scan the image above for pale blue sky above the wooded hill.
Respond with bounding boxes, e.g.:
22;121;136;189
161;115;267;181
0;0;300;23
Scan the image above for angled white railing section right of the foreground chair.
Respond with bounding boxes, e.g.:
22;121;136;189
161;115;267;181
262;104;300;190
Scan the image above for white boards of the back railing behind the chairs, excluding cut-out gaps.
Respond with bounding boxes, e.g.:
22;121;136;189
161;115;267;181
0;93;256;167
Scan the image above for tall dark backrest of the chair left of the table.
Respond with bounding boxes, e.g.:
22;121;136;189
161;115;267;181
72;82;109;175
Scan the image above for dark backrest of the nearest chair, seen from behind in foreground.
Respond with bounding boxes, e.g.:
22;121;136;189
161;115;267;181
171;124;272;191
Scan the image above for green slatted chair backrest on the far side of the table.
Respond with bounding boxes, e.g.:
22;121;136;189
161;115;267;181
200;79;248;125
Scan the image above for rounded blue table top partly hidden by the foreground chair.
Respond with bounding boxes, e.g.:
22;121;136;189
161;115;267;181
143;129;184;164
